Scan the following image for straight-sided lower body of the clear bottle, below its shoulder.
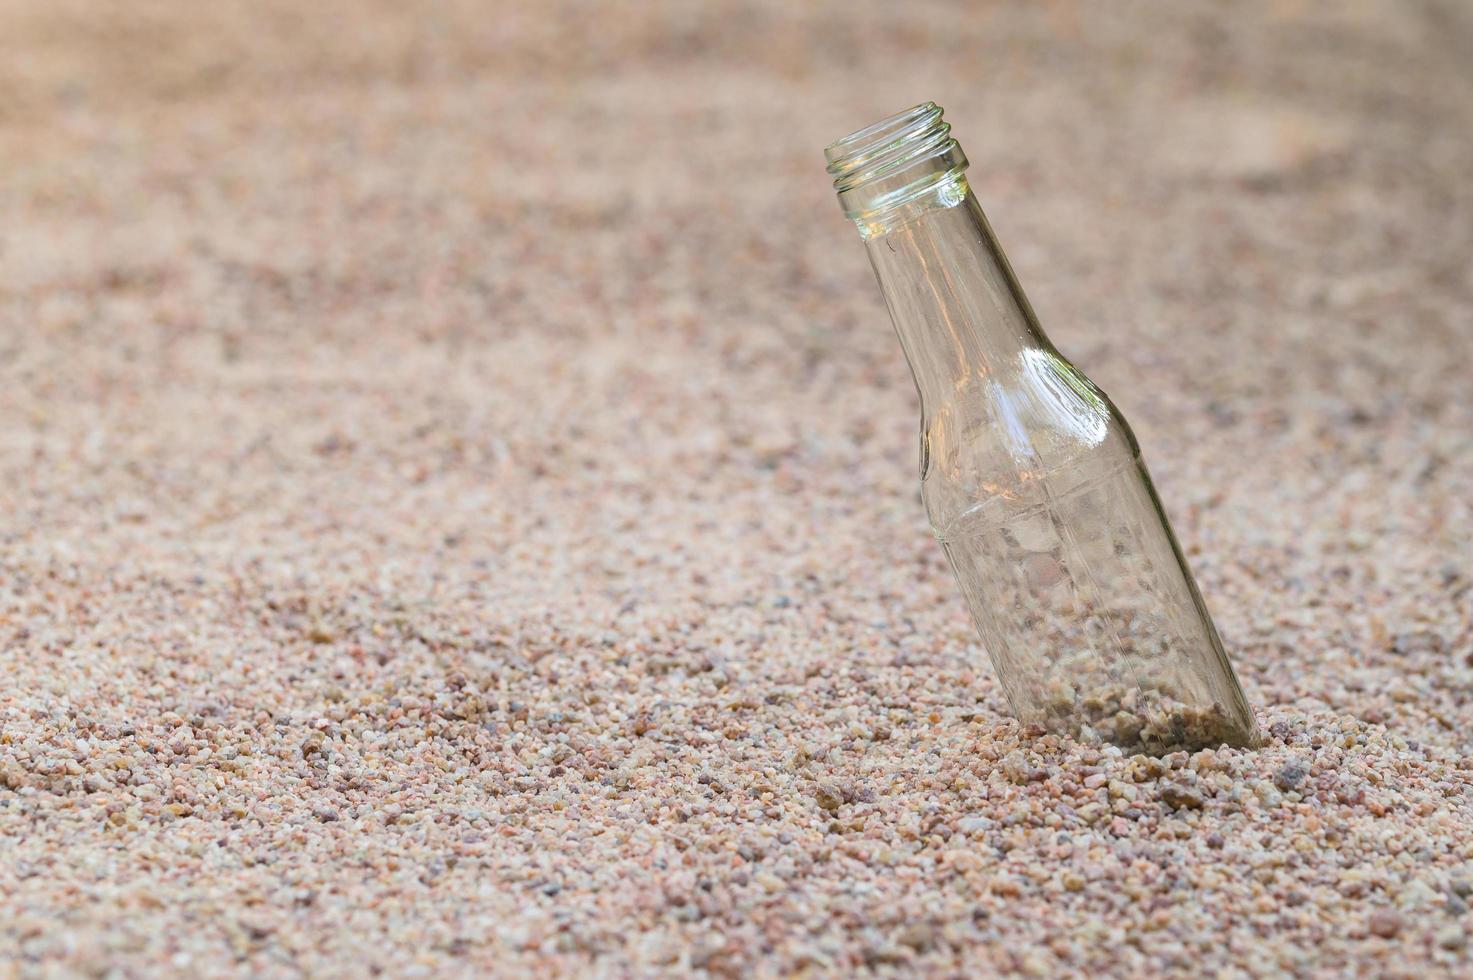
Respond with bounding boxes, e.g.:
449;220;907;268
937;460;1255;753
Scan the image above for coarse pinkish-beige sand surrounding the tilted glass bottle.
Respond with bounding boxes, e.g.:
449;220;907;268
0;0;1473;977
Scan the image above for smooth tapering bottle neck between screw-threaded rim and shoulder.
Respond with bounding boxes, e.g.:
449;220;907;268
866;179;1052;405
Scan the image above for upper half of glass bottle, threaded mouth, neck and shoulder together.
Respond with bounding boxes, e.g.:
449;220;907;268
828;103;1113;501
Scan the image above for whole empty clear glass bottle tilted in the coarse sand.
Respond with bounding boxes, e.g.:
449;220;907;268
826;103;1258;753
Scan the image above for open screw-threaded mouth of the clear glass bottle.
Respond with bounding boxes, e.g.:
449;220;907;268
823;102;966;221
